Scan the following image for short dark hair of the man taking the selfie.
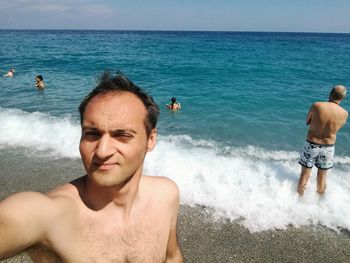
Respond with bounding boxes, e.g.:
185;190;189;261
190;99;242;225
79;71;159;136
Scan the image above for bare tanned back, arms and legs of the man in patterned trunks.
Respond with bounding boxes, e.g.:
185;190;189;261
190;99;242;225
297;91;348;195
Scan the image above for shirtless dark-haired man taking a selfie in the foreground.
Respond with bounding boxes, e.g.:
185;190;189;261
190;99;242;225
0;73;183;263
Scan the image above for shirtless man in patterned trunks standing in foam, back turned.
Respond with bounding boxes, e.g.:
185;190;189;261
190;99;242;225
298;85;348;195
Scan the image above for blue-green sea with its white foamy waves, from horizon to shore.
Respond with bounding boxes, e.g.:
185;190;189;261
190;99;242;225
0;30;350;231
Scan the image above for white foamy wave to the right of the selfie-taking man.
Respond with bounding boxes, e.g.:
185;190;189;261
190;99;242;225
145;136;350;231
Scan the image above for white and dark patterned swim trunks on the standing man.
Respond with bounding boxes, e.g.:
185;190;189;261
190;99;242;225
299;140;335;170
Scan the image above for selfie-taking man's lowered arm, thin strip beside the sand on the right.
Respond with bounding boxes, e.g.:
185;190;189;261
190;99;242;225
166;185;183;263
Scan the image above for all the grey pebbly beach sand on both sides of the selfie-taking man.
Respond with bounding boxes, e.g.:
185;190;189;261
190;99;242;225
0;151;350;263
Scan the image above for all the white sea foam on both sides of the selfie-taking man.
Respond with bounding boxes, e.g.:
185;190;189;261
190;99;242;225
0;108;350;231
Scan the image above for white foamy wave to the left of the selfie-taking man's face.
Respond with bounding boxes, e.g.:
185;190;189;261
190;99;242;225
0;108;80;158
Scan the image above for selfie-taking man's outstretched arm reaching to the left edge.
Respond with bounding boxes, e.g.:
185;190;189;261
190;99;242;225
0;192;52;259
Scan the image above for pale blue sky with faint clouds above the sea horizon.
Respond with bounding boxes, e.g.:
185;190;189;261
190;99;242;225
0;0;350;33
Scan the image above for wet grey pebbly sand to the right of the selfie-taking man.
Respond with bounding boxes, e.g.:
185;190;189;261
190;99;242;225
178;206;350;262
